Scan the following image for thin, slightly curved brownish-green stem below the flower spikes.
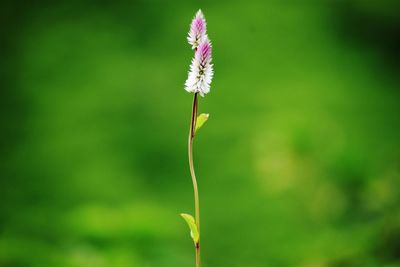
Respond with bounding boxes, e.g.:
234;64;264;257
188;93;200;267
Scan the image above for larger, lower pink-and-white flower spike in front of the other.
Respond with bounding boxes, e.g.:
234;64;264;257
185;37;214;96
